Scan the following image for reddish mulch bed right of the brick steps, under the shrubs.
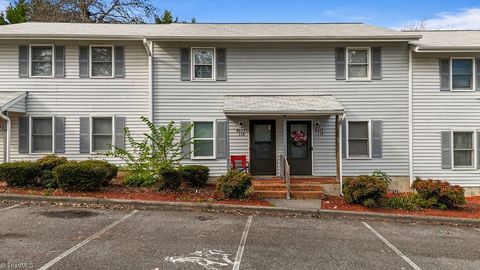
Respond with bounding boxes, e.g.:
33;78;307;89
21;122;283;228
322;195;480;218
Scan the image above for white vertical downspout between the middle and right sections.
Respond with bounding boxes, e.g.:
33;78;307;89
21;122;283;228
408;47;418;185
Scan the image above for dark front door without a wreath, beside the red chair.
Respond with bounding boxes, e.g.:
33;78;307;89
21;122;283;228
250;120;276;175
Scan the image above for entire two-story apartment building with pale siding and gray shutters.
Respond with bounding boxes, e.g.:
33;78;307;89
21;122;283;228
0;23;480;194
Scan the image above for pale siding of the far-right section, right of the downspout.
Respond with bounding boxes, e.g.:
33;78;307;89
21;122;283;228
413;53;480;187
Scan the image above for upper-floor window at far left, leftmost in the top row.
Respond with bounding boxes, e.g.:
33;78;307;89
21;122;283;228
30;45;54;77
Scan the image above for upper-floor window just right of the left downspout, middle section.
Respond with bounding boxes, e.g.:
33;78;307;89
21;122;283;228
192;48;215;80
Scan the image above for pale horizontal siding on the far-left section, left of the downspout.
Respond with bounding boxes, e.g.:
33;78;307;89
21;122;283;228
0;40;149;162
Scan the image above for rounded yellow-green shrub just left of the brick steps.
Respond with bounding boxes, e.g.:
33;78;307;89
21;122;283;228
217;170;252;199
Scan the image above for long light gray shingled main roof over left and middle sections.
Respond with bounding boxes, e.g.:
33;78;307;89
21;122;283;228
0;22;420;41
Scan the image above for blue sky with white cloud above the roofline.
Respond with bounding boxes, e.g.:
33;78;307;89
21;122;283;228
0;0;480;29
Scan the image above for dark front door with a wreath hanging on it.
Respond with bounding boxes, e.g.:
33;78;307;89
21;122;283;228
287;121;312;175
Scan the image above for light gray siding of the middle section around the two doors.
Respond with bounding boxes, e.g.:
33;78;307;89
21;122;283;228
154;42;408;176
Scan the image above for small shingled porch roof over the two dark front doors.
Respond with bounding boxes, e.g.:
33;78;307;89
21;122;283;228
223;95;345;116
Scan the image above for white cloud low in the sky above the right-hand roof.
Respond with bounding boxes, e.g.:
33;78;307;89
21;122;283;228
404;8;480;30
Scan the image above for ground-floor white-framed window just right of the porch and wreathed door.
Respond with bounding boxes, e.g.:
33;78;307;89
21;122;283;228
347;121;371;158
